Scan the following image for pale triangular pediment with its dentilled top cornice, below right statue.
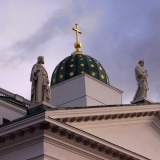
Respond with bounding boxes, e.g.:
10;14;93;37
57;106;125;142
47;104;160;160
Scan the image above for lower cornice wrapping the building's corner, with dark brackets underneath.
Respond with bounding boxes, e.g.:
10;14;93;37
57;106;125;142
0;112;147;160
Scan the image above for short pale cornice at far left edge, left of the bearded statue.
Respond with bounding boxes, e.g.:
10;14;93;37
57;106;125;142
0;100;27;115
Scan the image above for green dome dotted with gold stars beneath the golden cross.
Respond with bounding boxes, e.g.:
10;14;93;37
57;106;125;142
51;54;109;86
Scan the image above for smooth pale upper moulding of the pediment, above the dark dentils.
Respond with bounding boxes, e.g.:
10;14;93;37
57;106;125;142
46;104;160;119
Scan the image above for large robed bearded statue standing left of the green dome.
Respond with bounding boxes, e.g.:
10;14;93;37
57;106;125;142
30;56;51;104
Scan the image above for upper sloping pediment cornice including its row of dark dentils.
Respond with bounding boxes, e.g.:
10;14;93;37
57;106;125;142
46;104;160;123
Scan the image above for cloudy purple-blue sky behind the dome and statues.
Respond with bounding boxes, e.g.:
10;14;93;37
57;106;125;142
0;0;160;103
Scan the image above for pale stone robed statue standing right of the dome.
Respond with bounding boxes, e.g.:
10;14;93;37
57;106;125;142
133;60;149;101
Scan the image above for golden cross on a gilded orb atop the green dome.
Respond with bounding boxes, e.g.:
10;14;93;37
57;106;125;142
72;24;84;55
